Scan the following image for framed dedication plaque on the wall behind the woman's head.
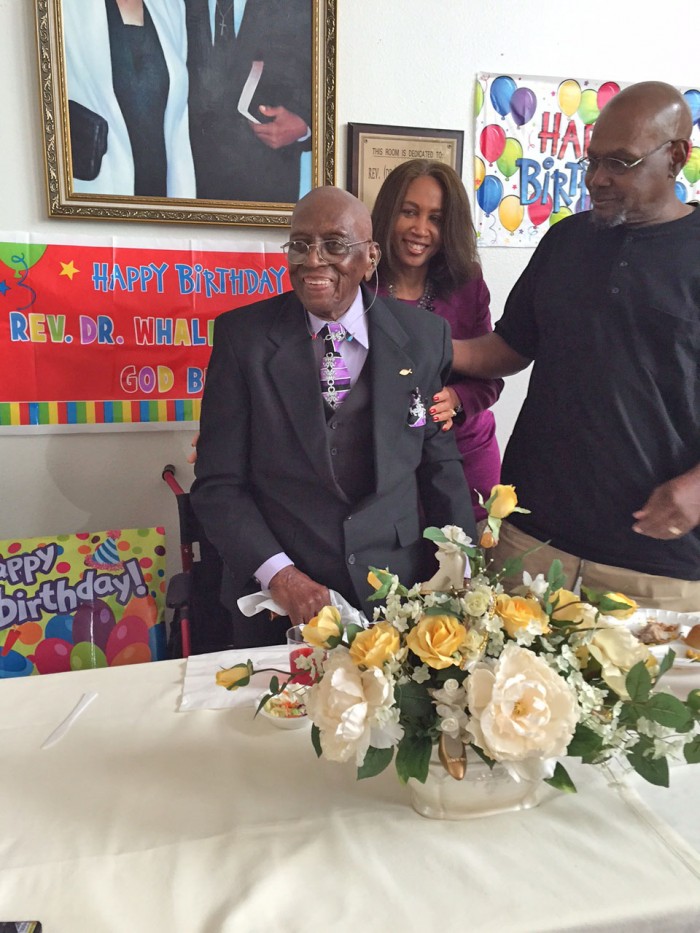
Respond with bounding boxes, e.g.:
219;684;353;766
347;123;464;211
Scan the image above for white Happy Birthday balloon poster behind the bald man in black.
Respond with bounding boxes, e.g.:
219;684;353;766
474;74;700;247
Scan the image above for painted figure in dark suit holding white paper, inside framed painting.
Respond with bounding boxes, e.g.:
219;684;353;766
185;0;312;203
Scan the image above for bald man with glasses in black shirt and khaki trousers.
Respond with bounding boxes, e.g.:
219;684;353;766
455;82;700;610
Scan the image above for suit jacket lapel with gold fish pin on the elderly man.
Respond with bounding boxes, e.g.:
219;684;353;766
365;298;418;494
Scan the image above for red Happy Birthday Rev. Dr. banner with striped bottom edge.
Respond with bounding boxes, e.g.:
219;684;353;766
0;234;290;433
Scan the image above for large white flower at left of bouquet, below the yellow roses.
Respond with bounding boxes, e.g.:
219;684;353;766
306;647;403;767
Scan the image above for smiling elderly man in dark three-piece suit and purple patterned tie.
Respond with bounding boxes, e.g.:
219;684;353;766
191;187;474;647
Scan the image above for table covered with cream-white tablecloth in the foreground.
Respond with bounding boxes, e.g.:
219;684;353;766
0;652;700;933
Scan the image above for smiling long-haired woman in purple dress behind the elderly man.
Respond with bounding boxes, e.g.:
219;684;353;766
372;159;503;521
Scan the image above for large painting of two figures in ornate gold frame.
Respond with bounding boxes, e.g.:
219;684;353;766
35;0;336;226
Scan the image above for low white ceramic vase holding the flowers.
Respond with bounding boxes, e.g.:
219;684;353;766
408;747;546;820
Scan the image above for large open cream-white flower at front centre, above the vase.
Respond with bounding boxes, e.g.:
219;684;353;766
467;642;580;778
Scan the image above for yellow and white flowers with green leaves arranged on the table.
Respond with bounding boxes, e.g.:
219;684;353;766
220;485;700;791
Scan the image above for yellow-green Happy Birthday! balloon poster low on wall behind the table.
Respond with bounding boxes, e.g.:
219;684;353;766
0;528;166;678
